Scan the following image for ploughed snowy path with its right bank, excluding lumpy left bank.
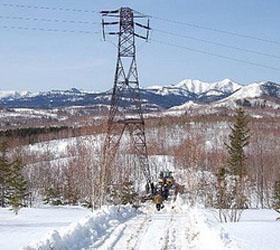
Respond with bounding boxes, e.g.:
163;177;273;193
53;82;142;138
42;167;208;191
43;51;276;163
92;210;237;250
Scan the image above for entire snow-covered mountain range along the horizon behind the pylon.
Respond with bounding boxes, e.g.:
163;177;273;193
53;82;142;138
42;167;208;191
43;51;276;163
0;79;280;112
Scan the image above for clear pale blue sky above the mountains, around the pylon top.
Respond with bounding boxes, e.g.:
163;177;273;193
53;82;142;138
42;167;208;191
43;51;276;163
0;0;280;92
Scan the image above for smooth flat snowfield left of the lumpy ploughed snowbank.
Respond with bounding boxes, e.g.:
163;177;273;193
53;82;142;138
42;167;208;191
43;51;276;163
0;207;91;250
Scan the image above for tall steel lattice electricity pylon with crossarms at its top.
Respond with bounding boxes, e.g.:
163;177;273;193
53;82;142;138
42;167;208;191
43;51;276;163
100;7;151;205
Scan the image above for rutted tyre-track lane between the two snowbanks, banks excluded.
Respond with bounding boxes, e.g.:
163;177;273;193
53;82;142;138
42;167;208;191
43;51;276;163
89;211;208;250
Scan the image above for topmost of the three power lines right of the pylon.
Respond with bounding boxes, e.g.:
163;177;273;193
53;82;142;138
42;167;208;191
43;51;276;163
150;16;280;46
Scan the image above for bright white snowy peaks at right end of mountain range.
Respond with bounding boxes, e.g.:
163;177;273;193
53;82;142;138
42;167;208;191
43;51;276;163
159;79;280;110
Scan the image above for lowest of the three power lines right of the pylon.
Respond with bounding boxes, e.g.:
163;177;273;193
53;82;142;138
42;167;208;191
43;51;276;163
151;39;280;72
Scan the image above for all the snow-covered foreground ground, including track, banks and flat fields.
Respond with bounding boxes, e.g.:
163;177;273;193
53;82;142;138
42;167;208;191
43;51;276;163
0;202;280;250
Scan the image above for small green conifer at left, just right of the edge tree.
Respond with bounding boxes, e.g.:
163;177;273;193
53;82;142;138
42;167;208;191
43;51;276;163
8;158;27;214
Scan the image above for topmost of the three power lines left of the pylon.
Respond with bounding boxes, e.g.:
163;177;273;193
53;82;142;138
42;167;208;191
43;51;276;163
2;3;97;13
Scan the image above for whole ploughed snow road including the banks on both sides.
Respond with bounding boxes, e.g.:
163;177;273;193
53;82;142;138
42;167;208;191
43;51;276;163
25;206;238;250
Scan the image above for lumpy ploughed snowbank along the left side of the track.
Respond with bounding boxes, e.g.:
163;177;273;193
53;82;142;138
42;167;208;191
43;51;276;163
24;206;137;250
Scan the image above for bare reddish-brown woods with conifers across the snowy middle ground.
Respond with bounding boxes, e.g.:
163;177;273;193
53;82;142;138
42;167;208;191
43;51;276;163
0;109;280;218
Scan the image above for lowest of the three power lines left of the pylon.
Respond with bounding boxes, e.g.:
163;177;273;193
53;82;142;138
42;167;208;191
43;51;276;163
0;25;100;34
